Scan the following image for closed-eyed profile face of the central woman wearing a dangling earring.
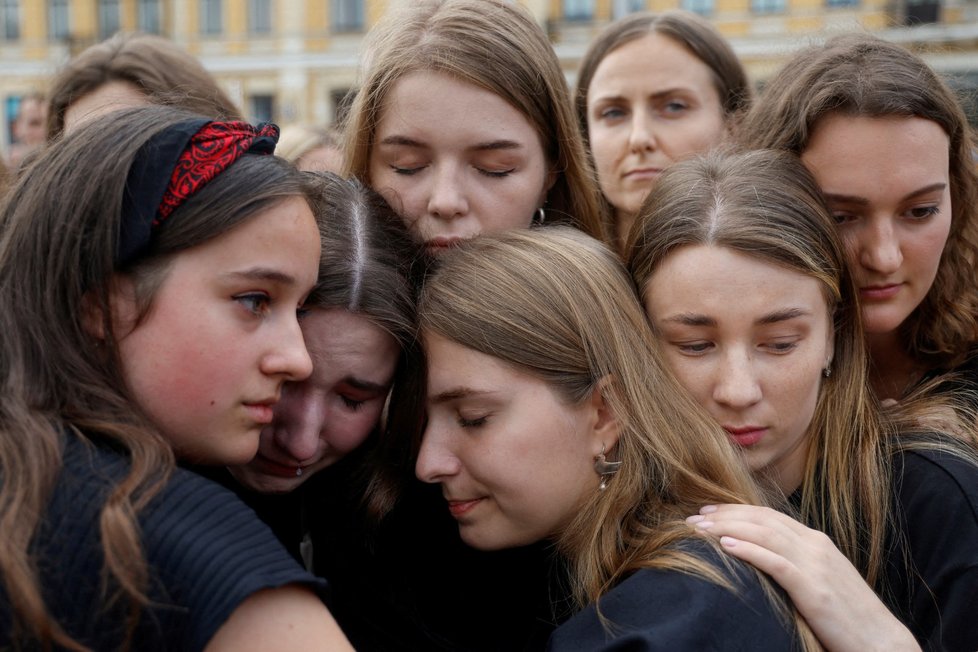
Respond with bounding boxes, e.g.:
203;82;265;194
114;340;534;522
415;333;604;550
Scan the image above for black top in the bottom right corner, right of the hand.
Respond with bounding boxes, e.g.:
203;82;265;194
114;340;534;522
883;451;978;652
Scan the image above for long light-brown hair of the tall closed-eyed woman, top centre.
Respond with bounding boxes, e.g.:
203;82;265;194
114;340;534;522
344;0;606;239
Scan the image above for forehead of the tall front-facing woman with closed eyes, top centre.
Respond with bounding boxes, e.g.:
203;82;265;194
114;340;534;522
375;71;539;145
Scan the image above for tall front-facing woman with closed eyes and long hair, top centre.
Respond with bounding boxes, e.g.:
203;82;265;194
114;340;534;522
345;0;604;253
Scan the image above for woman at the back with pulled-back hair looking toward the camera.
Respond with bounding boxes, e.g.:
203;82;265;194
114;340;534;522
575;11;751;252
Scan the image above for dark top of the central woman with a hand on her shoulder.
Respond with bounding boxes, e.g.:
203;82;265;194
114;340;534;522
548;542;799;652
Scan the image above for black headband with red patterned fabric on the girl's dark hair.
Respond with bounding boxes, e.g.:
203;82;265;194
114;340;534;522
116;119;278;267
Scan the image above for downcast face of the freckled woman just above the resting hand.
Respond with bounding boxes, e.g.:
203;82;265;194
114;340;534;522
643;245;834;492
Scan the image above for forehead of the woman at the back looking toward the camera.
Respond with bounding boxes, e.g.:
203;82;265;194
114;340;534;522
588;32;717;98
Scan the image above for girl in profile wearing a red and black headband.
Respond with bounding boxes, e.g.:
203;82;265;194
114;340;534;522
0;108;348;650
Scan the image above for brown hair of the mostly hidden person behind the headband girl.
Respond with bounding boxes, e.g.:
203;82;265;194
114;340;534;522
48;33;242;140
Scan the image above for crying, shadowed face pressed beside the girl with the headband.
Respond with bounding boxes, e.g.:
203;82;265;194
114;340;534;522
230;308;400;493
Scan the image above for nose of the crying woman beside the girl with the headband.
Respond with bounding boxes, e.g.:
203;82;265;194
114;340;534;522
273;383;328;463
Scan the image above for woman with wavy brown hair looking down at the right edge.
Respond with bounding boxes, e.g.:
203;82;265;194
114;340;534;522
742;34;978;399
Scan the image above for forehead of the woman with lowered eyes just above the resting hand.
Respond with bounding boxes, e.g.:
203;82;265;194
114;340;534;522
644;245;828;321
